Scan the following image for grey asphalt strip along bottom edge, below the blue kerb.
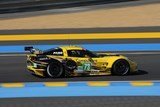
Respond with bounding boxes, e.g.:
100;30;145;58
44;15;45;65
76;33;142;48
0;96;160;107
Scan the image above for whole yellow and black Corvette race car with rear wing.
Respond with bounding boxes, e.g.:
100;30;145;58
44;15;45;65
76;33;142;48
25;46;137;78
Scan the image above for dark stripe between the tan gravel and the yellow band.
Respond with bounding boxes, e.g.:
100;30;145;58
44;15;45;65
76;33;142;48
0;26;160;35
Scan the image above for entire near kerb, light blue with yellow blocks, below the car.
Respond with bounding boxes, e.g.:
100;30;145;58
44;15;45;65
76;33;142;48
0;81;160;98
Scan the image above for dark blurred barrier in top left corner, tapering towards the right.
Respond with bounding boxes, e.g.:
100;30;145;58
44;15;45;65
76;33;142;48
0;0;136;14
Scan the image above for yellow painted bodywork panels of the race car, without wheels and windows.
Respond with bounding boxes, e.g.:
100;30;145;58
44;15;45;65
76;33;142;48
27;46;137;76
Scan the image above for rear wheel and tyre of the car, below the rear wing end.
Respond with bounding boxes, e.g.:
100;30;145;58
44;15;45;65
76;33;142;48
47;61;64;78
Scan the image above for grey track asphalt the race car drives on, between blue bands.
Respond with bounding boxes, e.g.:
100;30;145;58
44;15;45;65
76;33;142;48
0;54;160;83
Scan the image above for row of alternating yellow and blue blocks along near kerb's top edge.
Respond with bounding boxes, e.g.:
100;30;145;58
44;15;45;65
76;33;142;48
0;81;160;88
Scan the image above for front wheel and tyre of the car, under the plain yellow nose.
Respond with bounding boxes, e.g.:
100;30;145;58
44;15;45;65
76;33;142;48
111;59;130;76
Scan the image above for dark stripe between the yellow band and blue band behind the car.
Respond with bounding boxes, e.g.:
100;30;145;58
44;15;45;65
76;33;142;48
0;39;160;45
